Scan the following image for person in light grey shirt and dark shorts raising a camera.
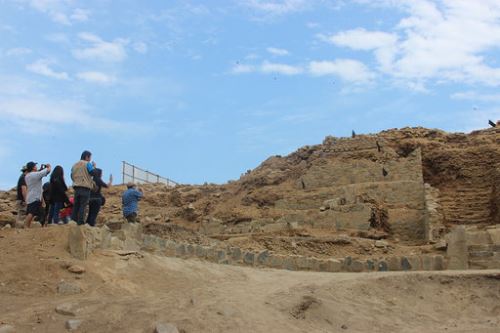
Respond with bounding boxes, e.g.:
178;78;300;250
24;162;51;228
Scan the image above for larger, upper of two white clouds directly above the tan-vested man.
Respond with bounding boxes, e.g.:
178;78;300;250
73;32;128;62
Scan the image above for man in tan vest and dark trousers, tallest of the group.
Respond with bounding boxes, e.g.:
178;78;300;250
71;150;95;225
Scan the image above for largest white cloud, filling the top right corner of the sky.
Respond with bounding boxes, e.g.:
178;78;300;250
323;0;500;86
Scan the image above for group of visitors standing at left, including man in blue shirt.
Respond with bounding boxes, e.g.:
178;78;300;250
17;150;143;228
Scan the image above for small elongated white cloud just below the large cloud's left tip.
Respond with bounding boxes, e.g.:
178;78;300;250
309;59;375;83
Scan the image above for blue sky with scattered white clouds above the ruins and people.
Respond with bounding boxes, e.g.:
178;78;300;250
0;0;500;189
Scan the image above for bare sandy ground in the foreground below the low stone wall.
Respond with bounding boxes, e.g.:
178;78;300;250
0;227;500;333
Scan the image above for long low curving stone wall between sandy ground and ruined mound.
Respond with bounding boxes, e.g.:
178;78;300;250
68;224;447;272
